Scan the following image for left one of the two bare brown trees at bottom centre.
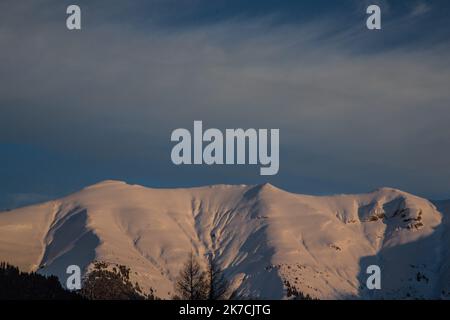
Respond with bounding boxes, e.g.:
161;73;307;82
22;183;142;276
175;252;208;300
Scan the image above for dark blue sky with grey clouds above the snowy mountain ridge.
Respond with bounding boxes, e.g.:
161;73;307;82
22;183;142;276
0;0;450;209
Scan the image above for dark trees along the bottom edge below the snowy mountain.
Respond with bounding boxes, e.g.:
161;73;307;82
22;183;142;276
0;253;311;300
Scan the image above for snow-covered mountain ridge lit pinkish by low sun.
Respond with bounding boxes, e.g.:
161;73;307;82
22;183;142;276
0;181;450;299
